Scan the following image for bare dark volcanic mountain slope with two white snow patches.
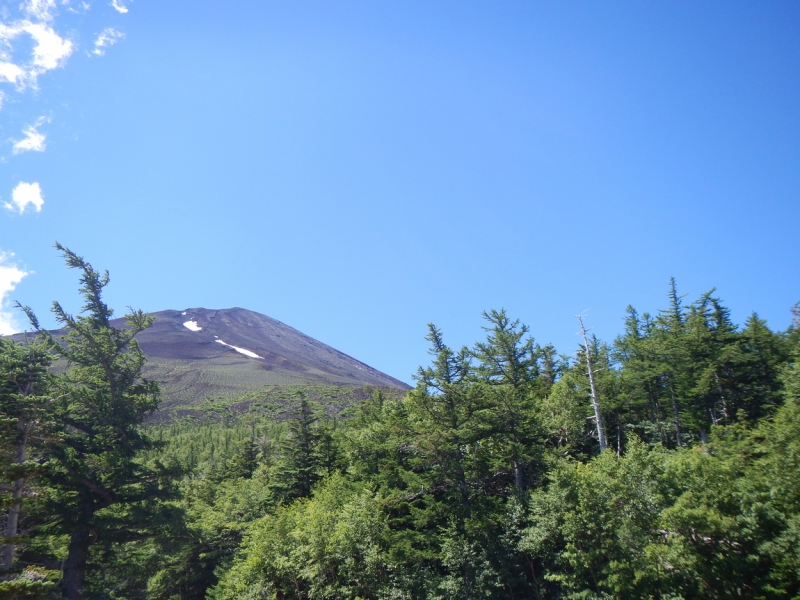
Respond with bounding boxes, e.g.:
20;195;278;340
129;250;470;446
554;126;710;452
9;308;410;409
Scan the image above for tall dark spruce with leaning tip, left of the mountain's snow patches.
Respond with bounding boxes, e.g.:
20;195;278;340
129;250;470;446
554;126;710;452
29;244;177;600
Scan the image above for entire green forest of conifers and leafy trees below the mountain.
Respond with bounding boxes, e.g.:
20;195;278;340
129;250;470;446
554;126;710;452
0;249;800;600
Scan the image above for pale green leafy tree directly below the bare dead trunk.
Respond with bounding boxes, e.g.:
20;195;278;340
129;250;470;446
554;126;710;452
520;440;664;598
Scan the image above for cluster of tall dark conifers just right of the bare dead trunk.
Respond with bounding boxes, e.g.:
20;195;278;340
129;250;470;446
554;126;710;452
614;281;788;446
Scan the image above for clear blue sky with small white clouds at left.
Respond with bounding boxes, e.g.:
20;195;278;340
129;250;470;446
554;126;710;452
0;0;800;381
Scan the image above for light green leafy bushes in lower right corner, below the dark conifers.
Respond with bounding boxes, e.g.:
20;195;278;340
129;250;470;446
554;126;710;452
521;403;800;598
